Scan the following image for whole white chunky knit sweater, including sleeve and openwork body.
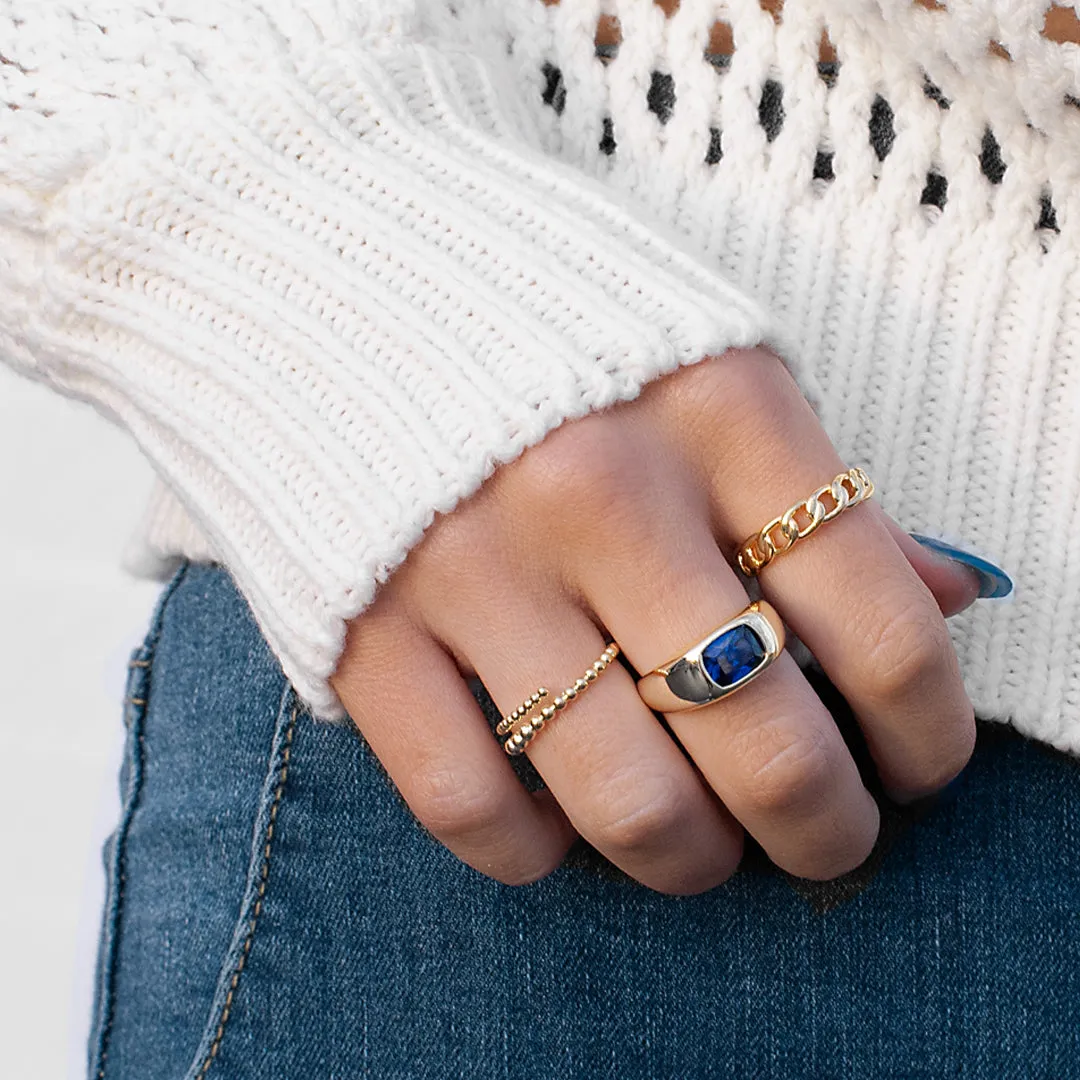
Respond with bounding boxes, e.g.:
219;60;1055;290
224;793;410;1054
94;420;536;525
0;0;1080;753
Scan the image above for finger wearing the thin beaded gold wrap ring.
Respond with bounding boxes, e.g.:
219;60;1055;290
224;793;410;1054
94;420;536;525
425;588;743;894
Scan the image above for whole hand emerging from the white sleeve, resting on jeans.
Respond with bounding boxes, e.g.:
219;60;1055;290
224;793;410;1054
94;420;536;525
334;350;977;893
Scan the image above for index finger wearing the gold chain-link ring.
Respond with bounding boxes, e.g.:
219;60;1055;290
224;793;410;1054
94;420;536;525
710;345;975;800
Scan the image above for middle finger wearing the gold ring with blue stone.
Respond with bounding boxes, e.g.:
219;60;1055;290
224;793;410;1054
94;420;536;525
576;505;879;879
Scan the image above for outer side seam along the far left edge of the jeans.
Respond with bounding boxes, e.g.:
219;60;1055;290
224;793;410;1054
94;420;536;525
90;563;188;1080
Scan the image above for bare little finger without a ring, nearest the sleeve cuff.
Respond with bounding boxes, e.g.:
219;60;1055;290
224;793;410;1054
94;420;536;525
333;600;577;885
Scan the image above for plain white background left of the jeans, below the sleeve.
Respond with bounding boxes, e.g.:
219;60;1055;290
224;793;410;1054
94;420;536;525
0;367;158;1080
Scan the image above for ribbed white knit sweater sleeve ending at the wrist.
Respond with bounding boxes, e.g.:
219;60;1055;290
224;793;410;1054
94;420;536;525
0;0;802;717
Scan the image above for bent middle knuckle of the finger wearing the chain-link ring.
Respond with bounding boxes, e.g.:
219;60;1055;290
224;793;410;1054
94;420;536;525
863;598;953;701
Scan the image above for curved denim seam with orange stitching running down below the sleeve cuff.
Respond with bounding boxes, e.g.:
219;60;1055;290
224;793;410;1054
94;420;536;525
188;685;300;1080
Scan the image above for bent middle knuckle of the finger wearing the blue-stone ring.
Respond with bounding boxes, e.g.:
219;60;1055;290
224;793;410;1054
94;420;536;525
737;721;836;815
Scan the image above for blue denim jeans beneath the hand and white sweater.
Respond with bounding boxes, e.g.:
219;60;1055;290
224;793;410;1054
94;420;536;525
90;565;1080;1080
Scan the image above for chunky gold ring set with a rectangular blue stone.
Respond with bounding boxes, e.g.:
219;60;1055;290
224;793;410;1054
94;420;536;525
637;600;784;713
